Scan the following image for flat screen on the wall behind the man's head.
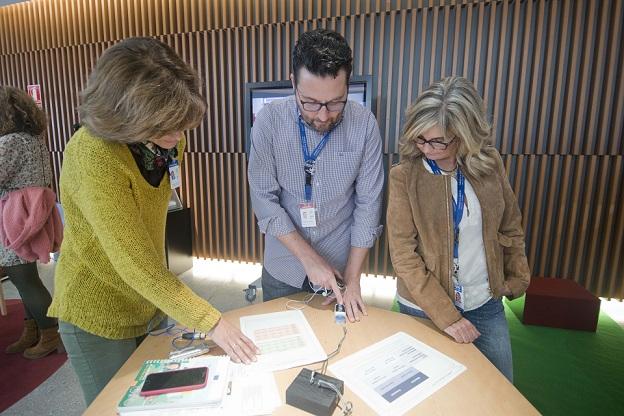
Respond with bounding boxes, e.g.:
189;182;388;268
244;76;373;154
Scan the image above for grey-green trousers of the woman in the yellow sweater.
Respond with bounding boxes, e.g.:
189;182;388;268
59;318;167;406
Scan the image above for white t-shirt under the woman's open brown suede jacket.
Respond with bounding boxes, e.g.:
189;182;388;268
397;158;492;311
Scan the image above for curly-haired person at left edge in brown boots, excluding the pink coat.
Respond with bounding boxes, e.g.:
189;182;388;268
0;86;62;359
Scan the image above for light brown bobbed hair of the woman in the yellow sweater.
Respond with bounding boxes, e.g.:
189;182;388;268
78;38;206;143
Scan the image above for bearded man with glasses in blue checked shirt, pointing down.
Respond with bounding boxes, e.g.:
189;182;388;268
248;29;384;322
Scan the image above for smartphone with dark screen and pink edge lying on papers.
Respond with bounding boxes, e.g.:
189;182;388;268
139;367;208;396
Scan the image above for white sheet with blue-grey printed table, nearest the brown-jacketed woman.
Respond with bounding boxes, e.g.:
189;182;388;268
329;332;466;416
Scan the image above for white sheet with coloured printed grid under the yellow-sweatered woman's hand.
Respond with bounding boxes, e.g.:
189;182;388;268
240;311;327;371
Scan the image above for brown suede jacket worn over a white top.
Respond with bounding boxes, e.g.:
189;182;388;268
387;152;530;330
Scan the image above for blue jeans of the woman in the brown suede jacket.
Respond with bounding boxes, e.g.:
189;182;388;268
399;298;513;383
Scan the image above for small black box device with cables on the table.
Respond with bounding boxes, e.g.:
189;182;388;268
286;368;344;416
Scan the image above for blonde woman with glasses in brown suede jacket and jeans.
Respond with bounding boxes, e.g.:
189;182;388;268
387;77;530;381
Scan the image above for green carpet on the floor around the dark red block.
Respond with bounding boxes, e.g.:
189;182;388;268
392;297;624;416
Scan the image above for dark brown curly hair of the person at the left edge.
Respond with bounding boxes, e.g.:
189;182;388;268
0;85;48;136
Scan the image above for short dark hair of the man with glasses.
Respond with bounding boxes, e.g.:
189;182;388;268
292;29;353;83
